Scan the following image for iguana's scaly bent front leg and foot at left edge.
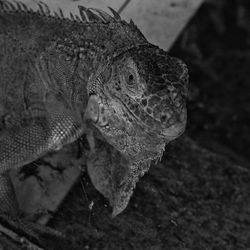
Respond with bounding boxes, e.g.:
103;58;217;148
0;112;82;249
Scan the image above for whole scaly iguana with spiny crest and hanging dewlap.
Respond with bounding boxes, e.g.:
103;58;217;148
0;0;188;248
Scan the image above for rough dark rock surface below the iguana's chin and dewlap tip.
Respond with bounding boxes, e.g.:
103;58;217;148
48;137;250;250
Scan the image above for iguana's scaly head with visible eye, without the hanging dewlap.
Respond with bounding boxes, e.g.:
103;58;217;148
86;46;188;162
